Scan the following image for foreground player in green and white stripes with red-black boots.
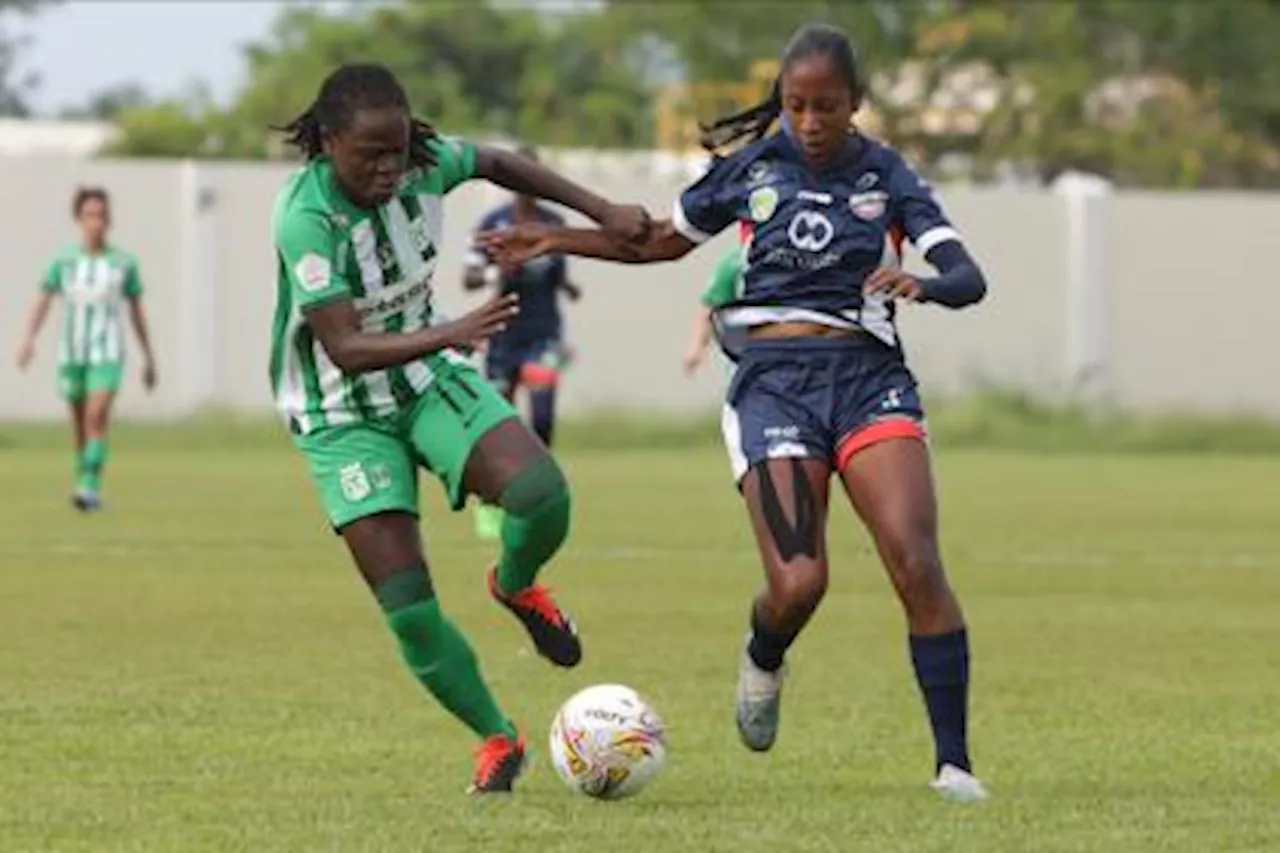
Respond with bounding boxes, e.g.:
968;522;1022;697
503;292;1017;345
271;64;648;793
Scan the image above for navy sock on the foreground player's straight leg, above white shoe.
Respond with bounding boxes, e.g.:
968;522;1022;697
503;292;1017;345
910;629;973;771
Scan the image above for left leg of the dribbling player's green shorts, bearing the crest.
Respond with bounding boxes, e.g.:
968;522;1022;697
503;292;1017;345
294;424;417;532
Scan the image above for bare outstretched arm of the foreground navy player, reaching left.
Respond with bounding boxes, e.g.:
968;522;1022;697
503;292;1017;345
477;219;695;264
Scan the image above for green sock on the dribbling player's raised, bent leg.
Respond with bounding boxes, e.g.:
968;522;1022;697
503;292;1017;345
498;456;570;596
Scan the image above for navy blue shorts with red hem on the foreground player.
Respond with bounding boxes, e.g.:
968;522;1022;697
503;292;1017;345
721;336;925;482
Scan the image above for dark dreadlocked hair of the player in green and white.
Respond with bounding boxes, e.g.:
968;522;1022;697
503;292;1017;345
273;63;439;168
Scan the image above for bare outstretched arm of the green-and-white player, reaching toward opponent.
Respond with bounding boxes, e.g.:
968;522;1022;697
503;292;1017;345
476;146;649;240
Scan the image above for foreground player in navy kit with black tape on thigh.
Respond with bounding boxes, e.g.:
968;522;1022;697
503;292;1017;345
485;26;987;800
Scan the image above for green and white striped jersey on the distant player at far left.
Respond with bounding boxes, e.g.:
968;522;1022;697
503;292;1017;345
40;245;142;365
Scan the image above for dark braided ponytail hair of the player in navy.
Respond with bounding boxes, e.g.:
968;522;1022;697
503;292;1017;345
699;23;863;154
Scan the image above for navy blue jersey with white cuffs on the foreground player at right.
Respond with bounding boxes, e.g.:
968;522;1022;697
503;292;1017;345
672;133;960;355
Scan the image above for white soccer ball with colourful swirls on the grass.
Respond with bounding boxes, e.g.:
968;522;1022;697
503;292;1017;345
550;684;667;799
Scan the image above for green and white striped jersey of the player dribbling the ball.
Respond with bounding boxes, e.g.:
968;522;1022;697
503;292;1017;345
271;138;476;434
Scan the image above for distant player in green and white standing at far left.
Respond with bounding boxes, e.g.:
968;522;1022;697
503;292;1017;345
18;187;156;512
